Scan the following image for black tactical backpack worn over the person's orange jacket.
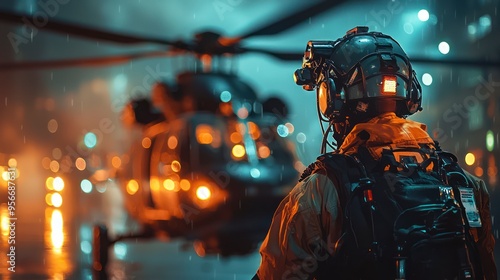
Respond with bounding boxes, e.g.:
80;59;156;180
301;145;482;280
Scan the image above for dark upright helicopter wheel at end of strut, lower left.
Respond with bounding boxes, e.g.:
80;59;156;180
92;225;110;280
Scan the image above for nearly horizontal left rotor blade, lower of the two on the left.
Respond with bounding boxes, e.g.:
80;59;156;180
0;51;173;71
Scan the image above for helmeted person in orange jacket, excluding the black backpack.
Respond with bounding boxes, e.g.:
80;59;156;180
253;27;497;280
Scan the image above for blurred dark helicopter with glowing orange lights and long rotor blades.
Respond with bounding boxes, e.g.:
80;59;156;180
0;1;500;278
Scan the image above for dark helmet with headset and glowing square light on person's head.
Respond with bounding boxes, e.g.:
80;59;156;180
294;26;422;150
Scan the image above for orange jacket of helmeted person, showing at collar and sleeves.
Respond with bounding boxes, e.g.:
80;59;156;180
254;113;497;280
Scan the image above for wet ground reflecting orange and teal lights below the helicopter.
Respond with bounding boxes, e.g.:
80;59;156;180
0;178;260;280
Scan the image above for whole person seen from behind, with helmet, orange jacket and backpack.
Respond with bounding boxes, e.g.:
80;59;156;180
254;27;496;280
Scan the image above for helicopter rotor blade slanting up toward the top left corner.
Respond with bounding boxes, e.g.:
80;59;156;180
0;10;188;49
